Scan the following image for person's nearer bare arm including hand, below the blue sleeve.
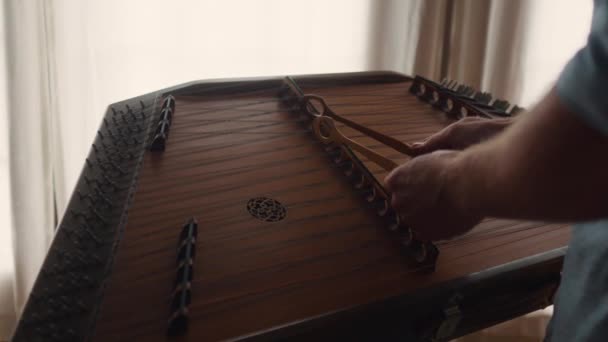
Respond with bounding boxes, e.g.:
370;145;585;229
385;90;608;240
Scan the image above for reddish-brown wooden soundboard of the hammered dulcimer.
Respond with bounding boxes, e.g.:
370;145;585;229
94;82;570;341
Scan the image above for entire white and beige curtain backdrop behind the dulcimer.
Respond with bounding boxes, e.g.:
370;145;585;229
0;0;592;340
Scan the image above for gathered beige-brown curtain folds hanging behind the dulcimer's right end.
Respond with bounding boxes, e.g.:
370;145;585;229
371;0;532;105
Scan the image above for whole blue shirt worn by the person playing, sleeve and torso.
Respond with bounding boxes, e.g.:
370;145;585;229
547;0;608;342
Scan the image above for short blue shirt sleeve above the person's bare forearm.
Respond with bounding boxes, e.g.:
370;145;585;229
557;0;608;135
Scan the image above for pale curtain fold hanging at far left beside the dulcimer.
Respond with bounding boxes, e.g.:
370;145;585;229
5;0;54;313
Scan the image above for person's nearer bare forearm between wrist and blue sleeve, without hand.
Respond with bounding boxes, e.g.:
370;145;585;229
446;91;608;221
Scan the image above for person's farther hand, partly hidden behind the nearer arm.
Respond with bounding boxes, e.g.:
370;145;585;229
412;117;513;155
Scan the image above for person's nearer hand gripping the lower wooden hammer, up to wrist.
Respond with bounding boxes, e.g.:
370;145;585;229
385;151;482;241
